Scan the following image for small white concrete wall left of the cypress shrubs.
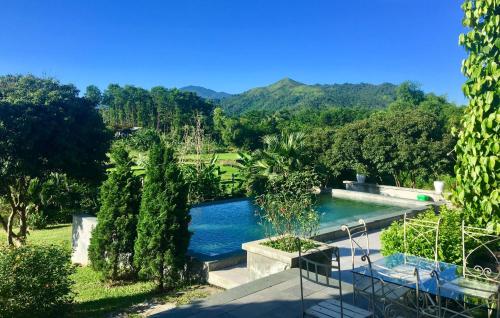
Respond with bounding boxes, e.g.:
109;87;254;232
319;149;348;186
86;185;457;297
71;214;97;265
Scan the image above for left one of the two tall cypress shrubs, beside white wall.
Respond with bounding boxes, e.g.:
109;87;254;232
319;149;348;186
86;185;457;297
89;145;141;280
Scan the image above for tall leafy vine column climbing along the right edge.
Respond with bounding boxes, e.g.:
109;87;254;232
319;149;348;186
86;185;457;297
454;0;500;233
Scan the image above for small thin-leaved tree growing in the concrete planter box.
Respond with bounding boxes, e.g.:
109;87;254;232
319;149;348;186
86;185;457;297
256;171;319;252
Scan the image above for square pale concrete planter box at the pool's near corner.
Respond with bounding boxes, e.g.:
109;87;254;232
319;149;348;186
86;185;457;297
241;238;334;280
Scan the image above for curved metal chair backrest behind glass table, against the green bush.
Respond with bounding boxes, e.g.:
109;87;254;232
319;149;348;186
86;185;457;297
403;213;441;264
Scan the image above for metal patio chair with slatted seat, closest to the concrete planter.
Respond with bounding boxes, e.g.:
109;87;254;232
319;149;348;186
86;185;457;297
297;239;373;318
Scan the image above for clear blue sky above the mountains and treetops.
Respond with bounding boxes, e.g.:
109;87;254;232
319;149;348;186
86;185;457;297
0;0;465;103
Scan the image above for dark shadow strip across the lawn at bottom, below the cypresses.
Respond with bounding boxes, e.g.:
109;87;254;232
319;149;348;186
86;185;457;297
70;290;158;318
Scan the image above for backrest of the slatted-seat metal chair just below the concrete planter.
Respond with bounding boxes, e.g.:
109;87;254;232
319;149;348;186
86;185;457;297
297;238;343;316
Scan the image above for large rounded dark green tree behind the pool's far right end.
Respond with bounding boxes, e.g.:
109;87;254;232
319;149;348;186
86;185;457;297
322;89;460;187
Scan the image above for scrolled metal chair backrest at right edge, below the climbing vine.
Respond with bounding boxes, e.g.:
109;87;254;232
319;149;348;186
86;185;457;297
462;221;500;284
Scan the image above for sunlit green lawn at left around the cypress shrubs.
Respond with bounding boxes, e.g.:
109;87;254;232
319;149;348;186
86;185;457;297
0;224;217;318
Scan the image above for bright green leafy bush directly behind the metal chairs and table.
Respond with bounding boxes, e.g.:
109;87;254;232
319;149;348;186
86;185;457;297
381;206;462;264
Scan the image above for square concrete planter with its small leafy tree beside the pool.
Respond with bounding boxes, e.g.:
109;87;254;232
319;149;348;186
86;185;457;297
242;171;333;279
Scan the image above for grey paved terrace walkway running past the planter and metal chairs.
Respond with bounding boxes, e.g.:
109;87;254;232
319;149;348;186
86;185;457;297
152;231;382;318
